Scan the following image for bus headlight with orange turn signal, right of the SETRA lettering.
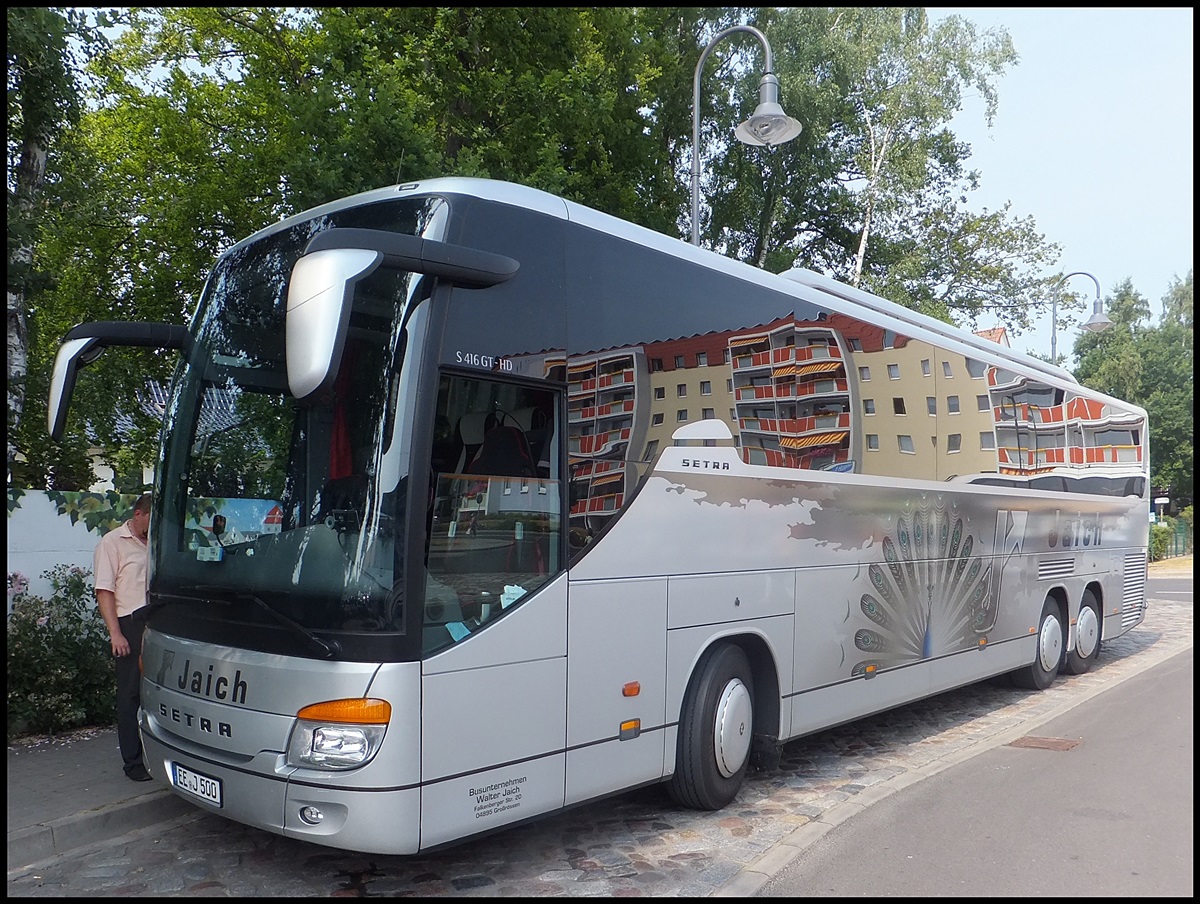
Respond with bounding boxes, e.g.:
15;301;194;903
287;698;391;770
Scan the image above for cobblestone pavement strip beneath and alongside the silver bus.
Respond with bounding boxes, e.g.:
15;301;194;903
8;600;1192;897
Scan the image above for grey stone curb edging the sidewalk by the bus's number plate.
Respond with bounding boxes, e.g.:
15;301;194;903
8;789;196;870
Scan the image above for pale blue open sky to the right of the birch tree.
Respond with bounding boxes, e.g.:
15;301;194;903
928;7;1194;367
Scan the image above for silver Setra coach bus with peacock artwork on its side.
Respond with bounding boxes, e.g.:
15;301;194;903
49;179;1150;854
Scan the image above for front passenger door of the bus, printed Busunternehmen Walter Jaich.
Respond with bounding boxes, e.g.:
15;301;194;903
420;373;566;850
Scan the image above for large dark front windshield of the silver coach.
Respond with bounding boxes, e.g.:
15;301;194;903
151;199;444;652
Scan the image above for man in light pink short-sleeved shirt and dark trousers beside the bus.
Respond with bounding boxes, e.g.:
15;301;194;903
92;493;151;782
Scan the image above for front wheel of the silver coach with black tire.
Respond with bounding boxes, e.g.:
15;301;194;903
667;643;754;810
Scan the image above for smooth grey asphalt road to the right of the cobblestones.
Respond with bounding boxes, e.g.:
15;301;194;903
757;577;1194;897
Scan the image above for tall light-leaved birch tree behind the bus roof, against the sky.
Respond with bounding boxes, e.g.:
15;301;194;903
702;7;1060;331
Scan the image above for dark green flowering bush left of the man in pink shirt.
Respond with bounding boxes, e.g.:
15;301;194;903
7;565;116;741
